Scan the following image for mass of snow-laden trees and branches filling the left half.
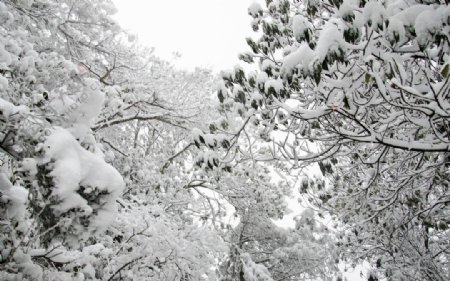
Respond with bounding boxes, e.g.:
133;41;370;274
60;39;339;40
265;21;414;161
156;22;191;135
0;0;226;280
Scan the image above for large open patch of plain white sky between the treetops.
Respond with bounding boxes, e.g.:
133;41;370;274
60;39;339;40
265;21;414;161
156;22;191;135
113;0;262;71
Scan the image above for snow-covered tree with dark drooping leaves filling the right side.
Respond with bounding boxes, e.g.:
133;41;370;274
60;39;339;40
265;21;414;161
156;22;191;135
211;0;450;280
